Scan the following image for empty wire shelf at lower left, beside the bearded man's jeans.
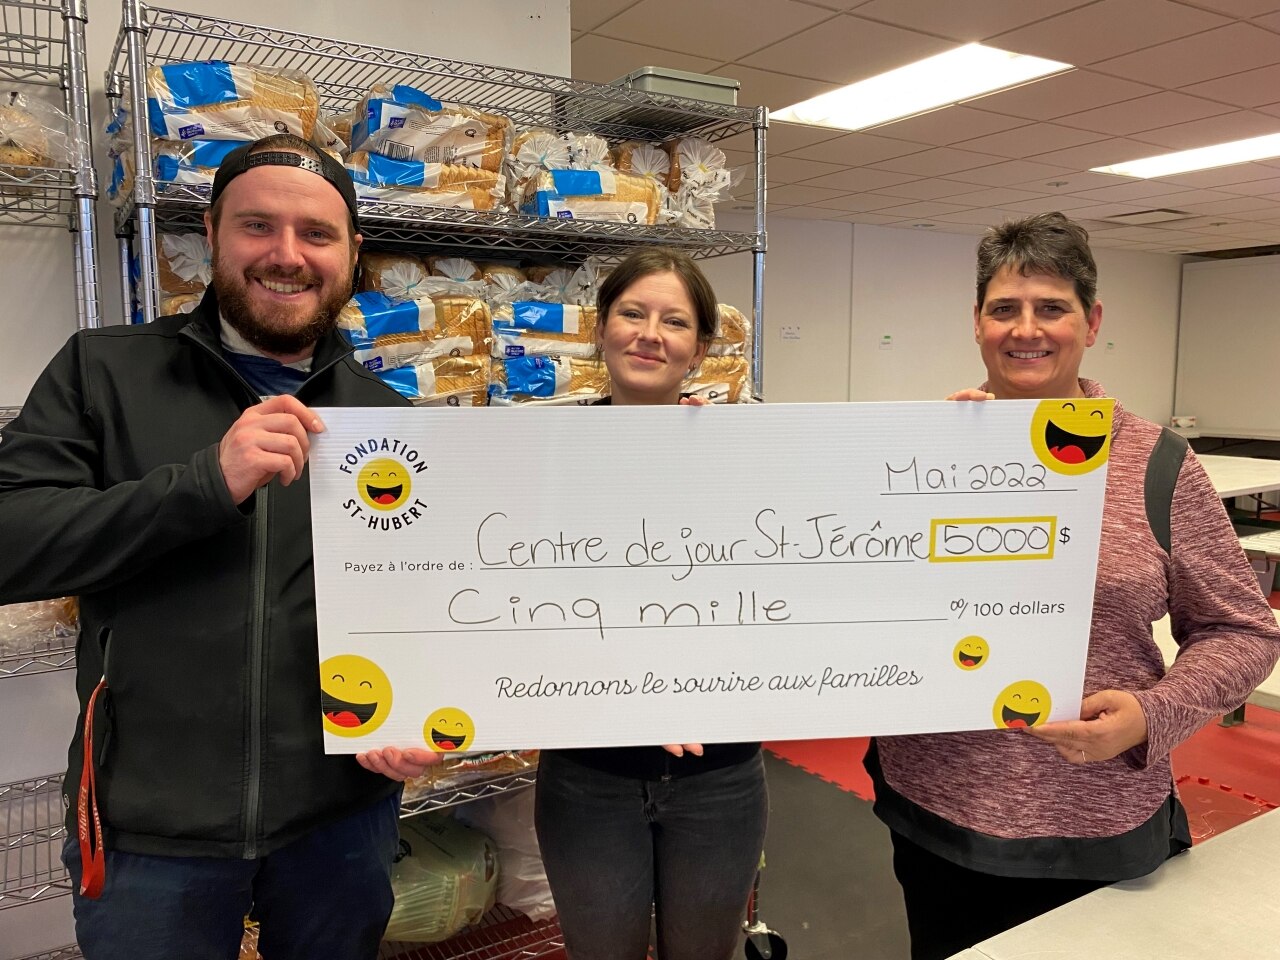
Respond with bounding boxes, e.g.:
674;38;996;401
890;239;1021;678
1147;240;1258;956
0;774;70;910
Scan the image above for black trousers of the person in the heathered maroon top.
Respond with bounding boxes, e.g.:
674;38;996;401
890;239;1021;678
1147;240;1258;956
890;831;1107;960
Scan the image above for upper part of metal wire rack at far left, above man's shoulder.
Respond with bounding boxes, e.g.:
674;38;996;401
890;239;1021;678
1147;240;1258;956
0;0;101;328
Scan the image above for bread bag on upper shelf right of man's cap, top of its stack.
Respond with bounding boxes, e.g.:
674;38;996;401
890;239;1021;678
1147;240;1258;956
351;83;512;173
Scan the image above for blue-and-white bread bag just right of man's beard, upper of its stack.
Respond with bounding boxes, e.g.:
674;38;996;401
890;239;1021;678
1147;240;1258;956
338;291;492;372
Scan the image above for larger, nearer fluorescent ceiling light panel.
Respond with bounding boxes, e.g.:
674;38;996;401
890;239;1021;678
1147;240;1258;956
769;44;1074;131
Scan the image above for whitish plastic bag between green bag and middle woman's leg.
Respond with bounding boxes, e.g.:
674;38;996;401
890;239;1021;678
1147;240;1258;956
454;790;556;920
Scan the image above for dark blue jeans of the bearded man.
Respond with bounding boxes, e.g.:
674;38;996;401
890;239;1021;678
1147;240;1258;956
63;792;399;960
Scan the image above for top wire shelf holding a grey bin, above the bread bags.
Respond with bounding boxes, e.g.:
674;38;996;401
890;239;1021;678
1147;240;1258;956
114;4;755;140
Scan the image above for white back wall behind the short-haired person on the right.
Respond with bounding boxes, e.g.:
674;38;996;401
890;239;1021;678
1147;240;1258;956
705;215;1181;422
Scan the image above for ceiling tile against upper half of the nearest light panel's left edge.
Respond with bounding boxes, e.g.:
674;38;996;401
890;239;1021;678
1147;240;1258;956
742;14;955;84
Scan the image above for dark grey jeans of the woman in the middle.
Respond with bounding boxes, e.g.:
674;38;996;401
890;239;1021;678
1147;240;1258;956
532;753;769;960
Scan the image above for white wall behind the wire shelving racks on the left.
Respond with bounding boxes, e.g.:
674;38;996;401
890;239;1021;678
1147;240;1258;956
0;0;570;407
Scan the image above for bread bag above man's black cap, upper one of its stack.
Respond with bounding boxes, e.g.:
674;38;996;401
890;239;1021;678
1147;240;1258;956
147;60;320;141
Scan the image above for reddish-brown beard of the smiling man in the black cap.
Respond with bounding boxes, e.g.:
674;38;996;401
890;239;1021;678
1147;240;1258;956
212;246;355;356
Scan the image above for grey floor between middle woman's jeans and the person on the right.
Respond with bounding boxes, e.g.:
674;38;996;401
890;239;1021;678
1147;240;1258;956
760;753;909;960
